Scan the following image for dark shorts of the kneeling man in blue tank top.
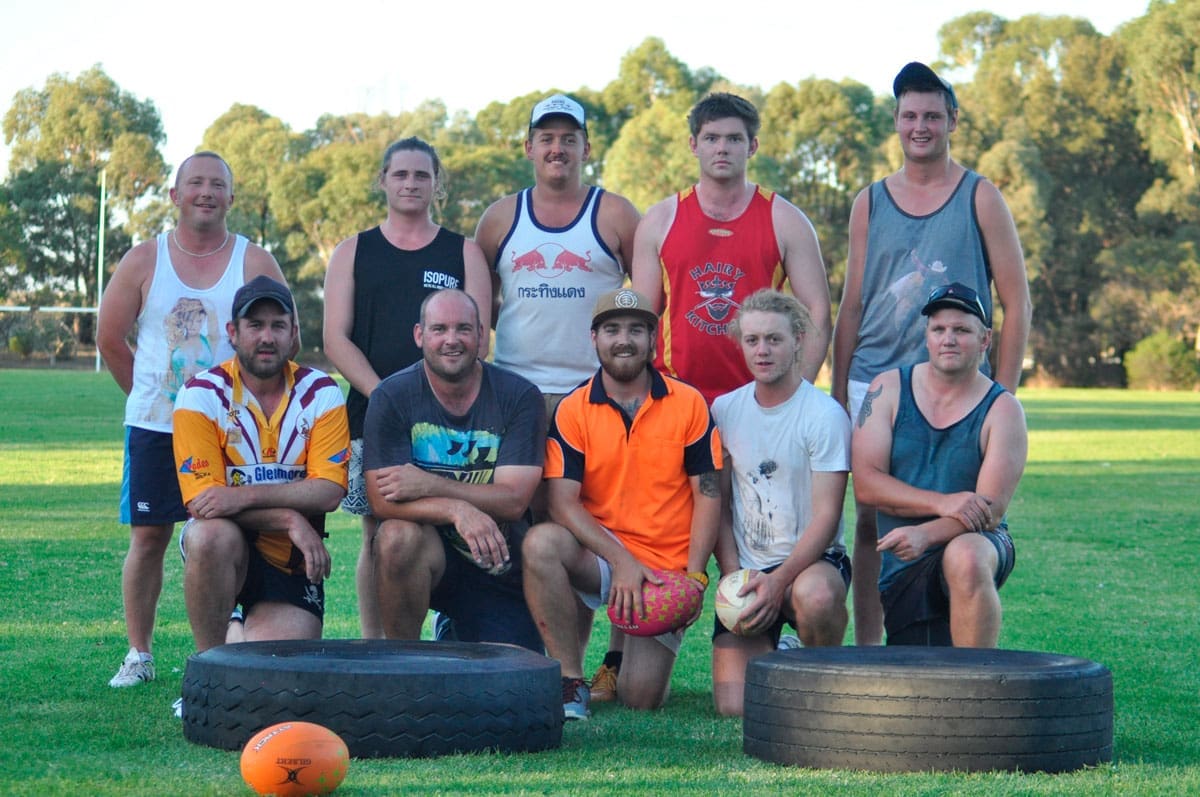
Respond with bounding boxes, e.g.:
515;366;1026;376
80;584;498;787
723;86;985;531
880;527;1016;647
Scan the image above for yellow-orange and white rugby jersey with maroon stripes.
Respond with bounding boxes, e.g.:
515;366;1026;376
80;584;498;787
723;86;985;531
172;358;350;573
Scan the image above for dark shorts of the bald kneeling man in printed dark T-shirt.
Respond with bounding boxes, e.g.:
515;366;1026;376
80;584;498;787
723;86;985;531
430;522;545;653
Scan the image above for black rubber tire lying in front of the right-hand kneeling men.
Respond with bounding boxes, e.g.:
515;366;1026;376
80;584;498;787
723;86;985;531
743;647;1112;772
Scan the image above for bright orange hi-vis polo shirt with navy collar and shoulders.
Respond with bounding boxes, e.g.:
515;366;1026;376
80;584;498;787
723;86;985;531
545;368;721;570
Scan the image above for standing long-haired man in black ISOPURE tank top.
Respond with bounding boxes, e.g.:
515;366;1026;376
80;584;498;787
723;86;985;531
324;138;492;637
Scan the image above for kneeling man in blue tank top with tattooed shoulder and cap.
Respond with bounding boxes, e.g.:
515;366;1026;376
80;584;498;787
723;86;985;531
851;282;1028;647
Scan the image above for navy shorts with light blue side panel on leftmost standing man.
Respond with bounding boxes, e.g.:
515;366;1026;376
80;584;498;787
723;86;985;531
121;426;187;526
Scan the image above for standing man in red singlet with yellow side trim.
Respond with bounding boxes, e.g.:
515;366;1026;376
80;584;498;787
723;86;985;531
632;92;829;405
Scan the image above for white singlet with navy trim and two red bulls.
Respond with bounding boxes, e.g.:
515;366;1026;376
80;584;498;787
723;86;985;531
493;186;625;392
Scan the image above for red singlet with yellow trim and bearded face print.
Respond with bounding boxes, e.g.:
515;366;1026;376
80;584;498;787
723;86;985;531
655;186;786;406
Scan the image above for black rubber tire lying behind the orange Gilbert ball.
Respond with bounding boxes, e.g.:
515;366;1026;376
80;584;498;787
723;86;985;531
182;640;563;759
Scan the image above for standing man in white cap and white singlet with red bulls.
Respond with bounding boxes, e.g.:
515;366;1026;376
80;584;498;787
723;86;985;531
475;94;641;702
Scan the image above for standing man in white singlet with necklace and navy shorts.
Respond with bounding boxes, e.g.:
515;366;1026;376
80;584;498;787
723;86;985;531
96;152;295;687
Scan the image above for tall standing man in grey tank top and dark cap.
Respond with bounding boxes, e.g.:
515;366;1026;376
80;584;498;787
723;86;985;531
832;62;1031;645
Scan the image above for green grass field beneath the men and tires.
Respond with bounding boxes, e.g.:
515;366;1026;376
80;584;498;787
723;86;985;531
0;370;1200;795
